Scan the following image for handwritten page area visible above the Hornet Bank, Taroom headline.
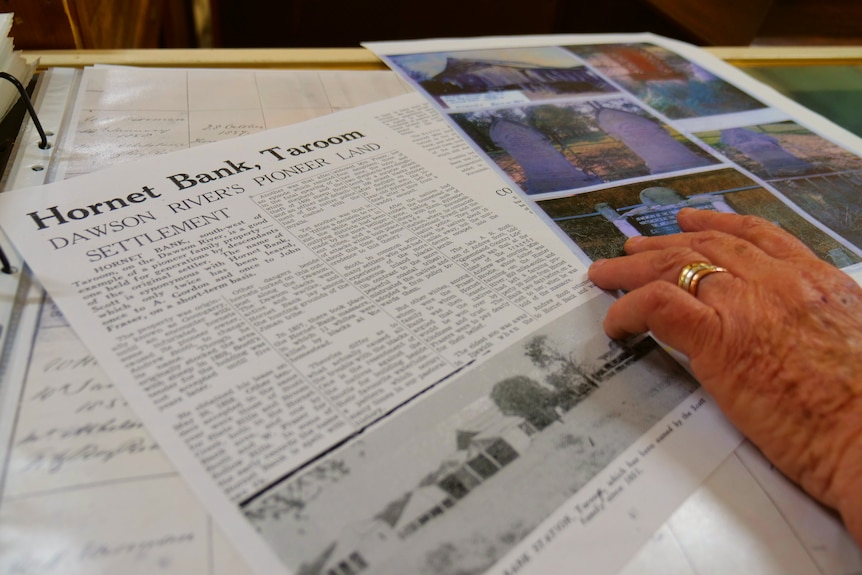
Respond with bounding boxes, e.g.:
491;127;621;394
58;67;410;177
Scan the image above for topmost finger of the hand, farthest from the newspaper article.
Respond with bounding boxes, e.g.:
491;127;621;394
677;208;816;259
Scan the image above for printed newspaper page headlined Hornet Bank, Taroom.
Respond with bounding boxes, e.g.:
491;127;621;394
0;94;739;573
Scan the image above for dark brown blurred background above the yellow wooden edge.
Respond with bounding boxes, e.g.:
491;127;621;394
0;0;862;50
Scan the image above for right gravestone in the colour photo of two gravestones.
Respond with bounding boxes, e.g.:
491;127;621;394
596;108;712;174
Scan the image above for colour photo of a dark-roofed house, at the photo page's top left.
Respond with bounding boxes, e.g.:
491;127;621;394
391;46;617;108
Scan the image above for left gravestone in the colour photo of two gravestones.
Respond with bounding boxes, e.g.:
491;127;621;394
488;118;602;194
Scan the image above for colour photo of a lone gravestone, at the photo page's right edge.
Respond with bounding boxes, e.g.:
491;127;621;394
696;122;862;249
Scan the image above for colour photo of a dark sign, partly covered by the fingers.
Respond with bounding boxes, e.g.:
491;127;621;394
536;165;860;267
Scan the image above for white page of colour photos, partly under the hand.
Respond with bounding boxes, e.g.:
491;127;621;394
366;34;862;279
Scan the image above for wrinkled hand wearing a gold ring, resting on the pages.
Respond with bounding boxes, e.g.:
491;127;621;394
590;209;862;545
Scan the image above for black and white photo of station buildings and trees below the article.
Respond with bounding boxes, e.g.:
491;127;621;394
243;294;698;575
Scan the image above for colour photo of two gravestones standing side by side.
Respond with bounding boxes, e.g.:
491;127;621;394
450;98;718;195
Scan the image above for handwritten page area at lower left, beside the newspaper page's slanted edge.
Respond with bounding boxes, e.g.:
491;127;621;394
0;307;230;573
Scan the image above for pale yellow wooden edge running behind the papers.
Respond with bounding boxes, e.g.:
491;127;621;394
23;46;862;70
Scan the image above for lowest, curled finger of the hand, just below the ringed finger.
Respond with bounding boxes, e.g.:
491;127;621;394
604;280;722;357
